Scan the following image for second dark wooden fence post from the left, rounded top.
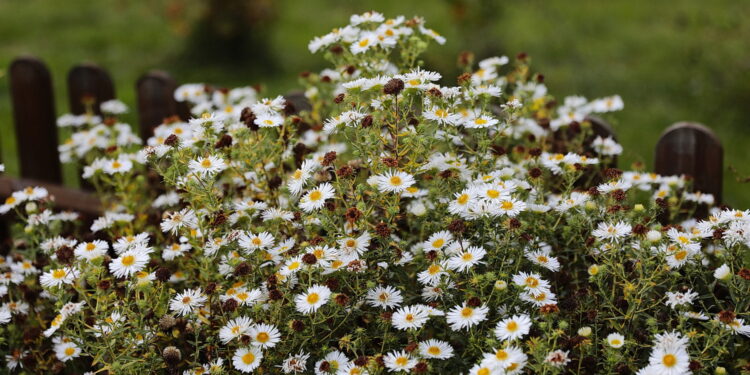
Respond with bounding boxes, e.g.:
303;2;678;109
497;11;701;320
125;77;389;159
68;63;115;115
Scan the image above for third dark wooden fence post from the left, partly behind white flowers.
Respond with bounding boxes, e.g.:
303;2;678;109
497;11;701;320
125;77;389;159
136;71;189;140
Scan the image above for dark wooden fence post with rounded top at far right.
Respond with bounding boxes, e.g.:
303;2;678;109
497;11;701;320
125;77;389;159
654;122;724;212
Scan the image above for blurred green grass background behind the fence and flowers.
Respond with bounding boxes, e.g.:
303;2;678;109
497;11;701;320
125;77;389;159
0;0;750;207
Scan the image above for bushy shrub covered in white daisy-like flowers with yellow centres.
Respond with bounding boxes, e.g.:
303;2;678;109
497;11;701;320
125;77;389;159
0;12;750;375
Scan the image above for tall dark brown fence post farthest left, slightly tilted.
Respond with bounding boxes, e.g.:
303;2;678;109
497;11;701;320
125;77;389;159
9;57;62;183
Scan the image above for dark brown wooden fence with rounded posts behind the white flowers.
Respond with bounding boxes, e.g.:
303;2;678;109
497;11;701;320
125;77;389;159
0;57;723;235
